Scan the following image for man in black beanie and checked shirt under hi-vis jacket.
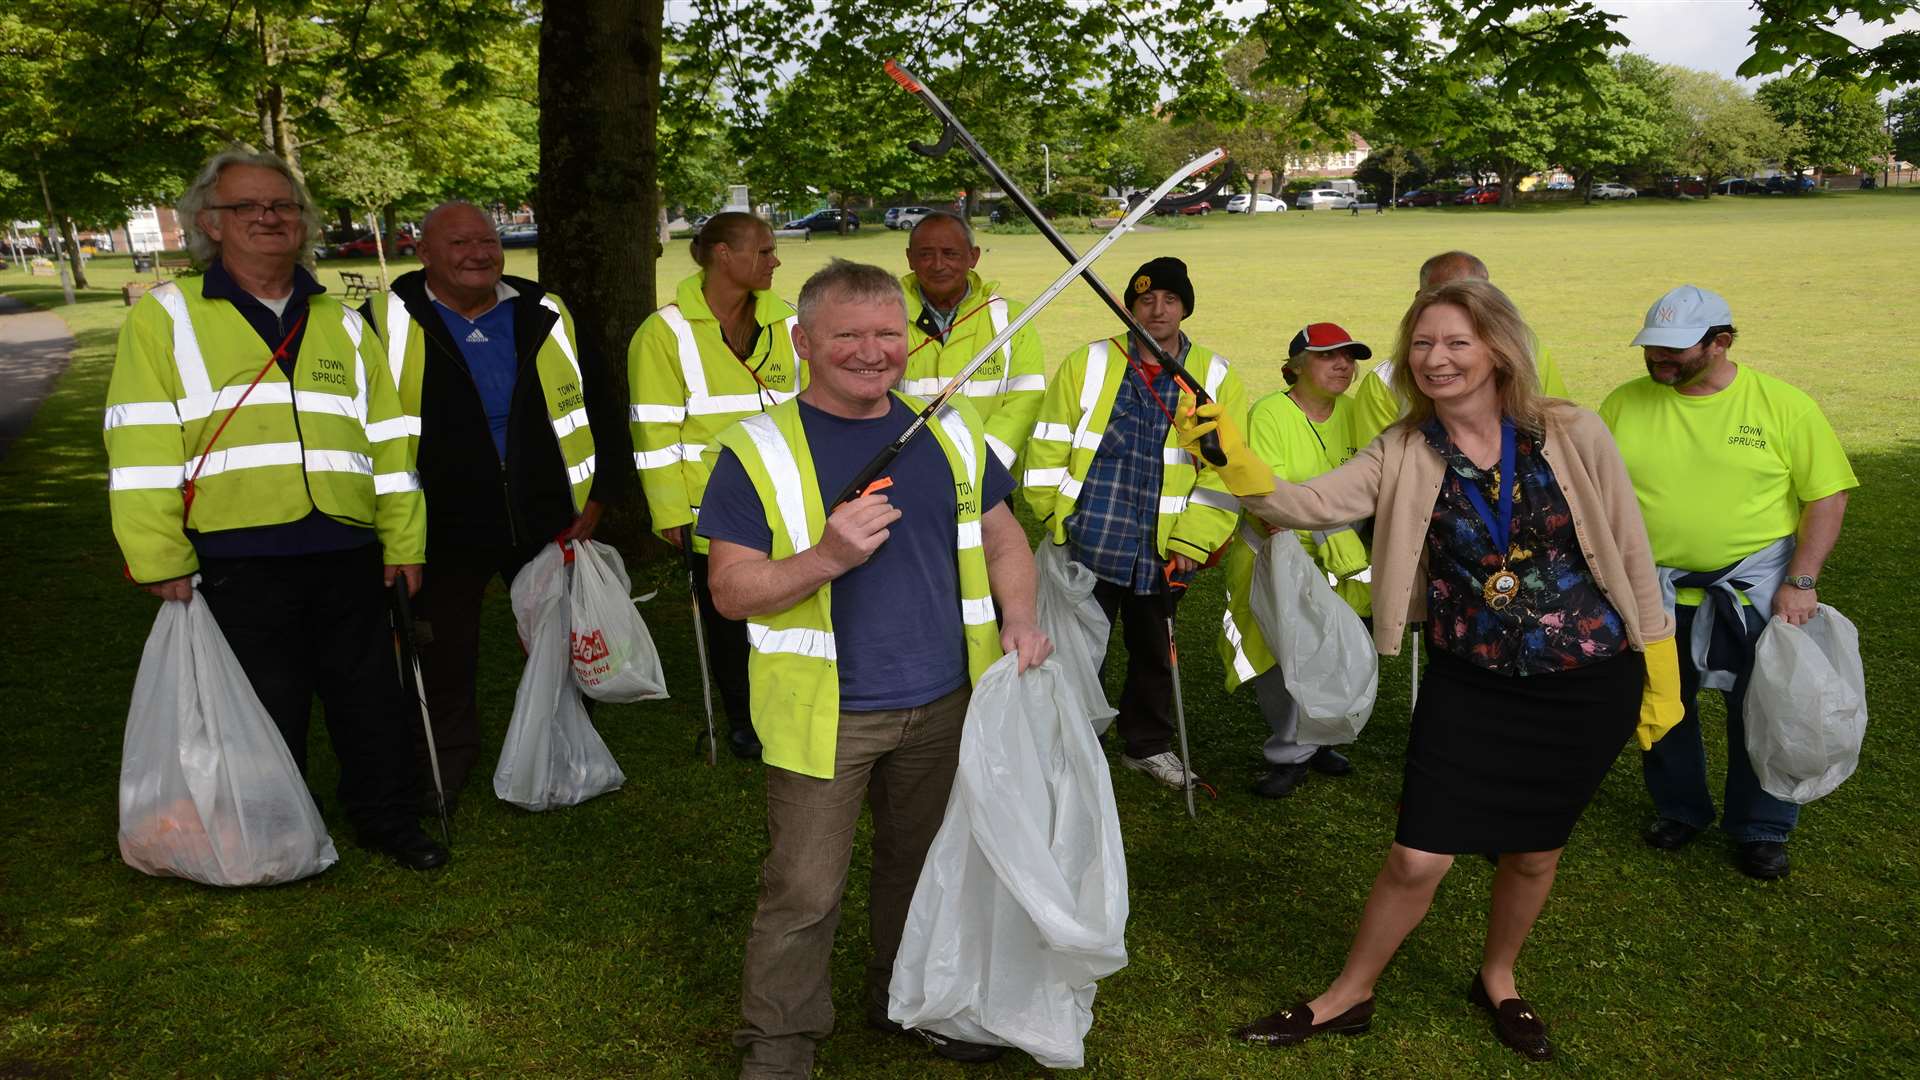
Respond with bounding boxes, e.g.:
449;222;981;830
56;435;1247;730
1021;256;1246;788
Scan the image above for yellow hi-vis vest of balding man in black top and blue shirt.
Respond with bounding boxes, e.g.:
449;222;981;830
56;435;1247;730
372;284;595;513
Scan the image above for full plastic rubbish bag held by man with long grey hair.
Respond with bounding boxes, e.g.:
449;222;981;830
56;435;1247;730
119;578;340;886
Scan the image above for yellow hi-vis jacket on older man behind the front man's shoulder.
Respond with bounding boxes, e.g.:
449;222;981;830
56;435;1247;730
900;271;1046;471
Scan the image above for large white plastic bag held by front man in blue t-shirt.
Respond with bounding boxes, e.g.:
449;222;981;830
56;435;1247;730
887;653;1127;1068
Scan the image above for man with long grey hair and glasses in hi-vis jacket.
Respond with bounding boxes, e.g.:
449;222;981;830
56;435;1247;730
106;148;447;871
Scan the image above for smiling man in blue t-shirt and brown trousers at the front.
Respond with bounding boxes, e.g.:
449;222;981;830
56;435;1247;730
699;259;1052;1076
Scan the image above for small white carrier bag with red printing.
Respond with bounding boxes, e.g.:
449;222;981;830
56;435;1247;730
570;540;666;701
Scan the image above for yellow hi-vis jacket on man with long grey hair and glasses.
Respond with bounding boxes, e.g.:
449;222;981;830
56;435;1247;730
104;282;426;582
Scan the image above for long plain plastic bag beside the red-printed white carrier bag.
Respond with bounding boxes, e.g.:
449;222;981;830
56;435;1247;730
493;546;626;811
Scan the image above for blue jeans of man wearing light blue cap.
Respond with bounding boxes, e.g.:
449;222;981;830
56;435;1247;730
1640;603;1799;844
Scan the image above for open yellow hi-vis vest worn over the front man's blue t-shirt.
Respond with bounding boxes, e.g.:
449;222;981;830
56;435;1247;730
720;394;1000;778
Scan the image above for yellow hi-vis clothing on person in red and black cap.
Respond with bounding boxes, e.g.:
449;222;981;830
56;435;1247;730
1217;392;1375;694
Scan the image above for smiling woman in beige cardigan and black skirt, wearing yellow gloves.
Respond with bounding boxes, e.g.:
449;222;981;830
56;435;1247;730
1181;279;1680;1061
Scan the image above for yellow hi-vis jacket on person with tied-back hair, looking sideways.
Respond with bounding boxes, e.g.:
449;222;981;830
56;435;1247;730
626;271;806;553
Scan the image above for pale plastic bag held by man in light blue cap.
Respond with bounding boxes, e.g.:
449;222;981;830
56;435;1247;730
1747;603;1866;803
